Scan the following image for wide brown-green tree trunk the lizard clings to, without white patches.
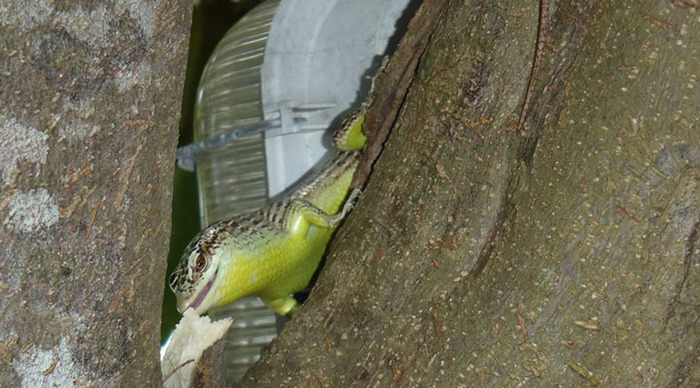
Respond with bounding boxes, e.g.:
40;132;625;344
243;0;700;387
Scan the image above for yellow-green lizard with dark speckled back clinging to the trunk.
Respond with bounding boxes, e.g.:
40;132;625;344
169;113;366;315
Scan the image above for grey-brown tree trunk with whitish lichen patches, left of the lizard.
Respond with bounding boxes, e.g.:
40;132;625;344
0;0;191;387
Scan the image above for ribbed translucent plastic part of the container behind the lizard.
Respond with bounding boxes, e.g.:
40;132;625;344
194;0;279;382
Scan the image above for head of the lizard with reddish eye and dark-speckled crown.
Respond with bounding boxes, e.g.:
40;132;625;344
169;224;220;315
